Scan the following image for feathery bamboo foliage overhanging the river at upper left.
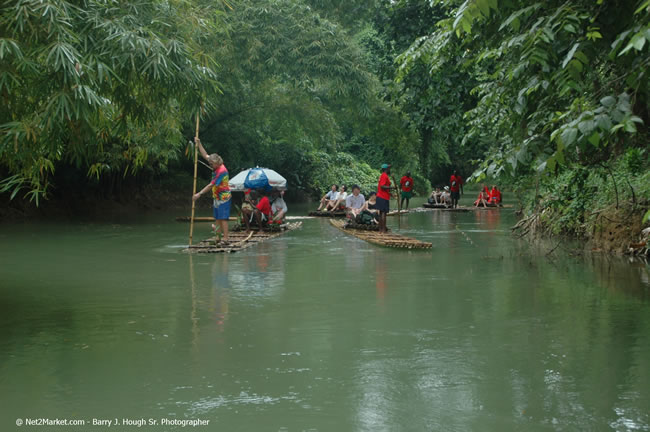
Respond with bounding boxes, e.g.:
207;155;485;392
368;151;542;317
0;0;221;201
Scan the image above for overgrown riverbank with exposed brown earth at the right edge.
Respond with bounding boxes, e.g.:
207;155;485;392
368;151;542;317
514;160;650;257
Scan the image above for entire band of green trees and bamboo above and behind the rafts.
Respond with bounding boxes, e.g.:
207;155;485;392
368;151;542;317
0;0;650;231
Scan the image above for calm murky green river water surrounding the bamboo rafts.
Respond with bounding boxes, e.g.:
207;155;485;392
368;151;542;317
0;201;650;431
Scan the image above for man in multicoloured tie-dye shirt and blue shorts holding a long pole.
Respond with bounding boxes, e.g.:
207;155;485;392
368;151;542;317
192;137;231;243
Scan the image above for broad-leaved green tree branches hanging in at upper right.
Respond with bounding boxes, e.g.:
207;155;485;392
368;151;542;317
398;0;650;221
